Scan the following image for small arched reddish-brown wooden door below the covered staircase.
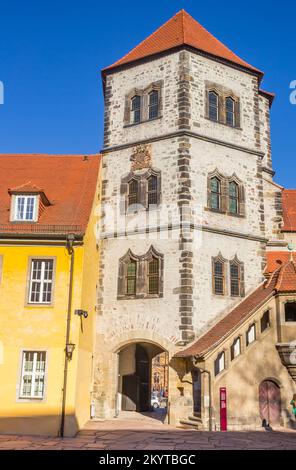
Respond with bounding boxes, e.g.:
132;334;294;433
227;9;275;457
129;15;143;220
259;379;281;424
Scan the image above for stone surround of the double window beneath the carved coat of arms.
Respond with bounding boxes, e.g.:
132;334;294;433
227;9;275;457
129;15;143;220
120;168;161;214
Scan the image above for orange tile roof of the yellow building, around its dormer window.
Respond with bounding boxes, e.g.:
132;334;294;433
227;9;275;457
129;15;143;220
0;154;100;234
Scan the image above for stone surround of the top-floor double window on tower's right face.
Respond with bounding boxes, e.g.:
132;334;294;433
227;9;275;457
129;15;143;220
205;80;242;130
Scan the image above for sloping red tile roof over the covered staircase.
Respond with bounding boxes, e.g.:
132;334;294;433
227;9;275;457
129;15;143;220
176;261;296;357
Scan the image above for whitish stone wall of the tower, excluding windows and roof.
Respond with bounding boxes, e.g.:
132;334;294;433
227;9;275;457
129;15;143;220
94;46;277;422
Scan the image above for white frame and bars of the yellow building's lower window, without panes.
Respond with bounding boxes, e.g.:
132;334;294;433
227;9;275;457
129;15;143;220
19;350;47;400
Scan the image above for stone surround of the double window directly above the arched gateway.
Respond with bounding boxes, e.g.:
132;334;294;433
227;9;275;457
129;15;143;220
117;245;164;300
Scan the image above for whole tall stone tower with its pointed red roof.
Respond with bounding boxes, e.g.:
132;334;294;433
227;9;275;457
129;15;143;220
93;10;273;422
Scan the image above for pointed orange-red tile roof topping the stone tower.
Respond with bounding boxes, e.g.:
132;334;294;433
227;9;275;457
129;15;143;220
103;10;263;75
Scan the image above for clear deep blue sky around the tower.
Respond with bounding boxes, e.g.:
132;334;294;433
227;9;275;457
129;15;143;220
0;0;296;187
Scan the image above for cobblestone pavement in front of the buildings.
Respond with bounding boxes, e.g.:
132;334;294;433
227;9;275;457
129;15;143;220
0;419;296;450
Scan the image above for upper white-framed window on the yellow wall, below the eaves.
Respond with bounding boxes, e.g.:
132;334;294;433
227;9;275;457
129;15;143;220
28;259;54;304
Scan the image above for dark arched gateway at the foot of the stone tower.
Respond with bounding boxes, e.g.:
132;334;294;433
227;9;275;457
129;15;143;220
116;342;168;415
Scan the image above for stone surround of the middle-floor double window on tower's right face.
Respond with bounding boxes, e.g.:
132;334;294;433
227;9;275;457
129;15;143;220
205;168;246;217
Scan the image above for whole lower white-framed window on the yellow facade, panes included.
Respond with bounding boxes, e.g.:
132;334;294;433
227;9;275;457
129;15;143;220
20;351;46;399
